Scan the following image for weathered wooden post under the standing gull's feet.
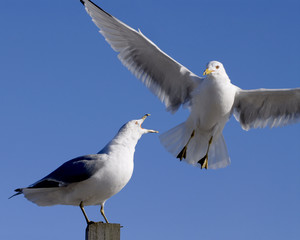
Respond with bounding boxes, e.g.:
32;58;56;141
85;222;121;240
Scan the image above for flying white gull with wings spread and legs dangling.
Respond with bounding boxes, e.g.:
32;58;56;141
80;0;300;169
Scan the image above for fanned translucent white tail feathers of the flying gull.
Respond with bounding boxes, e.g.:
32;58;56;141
159;122;230;169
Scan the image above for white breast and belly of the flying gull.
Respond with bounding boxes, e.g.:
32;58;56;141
191;81;234;128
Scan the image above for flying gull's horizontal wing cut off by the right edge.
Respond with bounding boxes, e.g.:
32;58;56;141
233;88;300;130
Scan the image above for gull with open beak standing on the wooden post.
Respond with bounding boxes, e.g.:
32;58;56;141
11;114;158;224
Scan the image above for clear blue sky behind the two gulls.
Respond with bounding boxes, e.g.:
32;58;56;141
0;0;300;240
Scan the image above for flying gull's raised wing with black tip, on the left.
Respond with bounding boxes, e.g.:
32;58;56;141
80;0;202;112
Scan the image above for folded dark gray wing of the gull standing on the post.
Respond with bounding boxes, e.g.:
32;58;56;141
29;154;103;188
